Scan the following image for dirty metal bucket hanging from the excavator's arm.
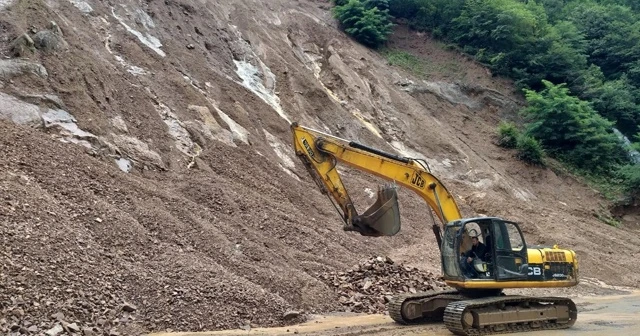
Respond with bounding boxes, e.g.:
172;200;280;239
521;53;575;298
354;185;400;236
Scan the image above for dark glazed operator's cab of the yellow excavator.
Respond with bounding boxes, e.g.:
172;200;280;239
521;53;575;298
442;217;530;287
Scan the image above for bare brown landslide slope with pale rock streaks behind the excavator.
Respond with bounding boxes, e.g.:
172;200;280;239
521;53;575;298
0;0;640;334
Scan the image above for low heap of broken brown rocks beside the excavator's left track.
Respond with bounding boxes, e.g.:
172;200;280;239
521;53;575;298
319;256;448;314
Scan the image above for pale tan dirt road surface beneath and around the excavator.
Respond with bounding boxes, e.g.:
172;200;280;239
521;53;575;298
149;291;640;336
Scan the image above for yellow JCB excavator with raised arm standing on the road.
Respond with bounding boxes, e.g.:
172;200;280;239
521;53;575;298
291;122;578;335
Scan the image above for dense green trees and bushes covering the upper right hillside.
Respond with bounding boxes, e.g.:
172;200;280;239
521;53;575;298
335;0;640;205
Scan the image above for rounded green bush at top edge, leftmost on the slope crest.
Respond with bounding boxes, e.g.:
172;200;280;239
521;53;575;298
333;0;393;48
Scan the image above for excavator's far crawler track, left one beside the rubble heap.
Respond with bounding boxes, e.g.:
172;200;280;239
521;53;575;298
387;290;467;324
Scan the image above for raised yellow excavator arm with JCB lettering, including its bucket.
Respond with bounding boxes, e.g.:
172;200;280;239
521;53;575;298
291;123;461;242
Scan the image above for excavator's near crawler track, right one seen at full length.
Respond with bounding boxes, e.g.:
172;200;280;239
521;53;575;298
444;296;578;336
